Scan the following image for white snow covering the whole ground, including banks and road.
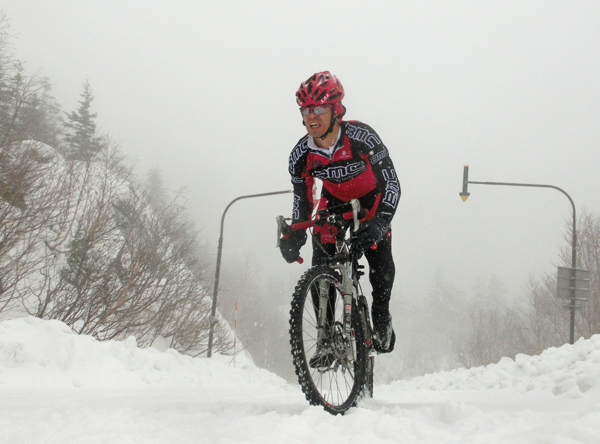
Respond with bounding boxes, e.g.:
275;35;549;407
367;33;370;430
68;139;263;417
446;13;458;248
0;317;600;444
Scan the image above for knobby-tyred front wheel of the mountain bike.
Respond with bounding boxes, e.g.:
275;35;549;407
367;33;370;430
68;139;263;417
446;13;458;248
290;266;368;415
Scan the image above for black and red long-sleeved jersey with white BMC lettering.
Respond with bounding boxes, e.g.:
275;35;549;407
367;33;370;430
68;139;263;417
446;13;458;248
289;121;400;223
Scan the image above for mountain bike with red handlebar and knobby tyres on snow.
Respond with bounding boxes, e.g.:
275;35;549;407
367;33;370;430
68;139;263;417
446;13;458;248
277;199;375;415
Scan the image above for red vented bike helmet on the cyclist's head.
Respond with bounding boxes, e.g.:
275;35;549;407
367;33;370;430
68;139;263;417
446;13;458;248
296;71;346;118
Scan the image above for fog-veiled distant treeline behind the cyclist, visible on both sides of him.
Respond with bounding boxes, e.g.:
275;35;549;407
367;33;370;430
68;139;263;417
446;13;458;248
219;210;600;383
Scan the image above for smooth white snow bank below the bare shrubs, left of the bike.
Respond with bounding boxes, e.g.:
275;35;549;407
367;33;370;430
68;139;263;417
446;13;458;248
0;317;286;391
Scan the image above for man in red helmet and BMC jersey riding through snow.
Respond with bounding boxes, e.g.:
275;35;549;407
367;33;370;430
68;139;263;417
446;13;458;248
280;71;400;360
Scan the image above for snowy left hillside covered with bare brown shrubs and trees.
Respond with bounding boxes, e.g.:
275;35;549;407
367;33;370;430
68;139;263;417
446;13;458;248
0;15;233;356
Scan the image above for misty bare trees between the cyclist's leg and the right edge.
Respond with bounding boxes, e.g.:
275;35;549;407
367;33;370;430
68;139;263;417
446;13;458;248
376;209;600;381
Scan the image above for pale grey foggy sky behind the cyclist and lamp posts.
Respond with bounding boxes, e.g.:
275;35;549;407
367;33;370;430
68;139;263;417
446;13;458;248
0;0;600;304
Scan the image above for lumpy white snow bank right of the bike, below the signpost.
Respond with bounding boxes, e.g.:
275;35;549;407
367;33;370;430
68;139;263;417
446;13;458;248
393;335;600;398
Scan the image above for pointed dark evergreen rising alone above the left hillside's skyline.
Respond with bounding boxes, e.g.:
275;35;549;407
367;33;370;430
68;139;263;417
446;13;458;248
65;80;102;160
